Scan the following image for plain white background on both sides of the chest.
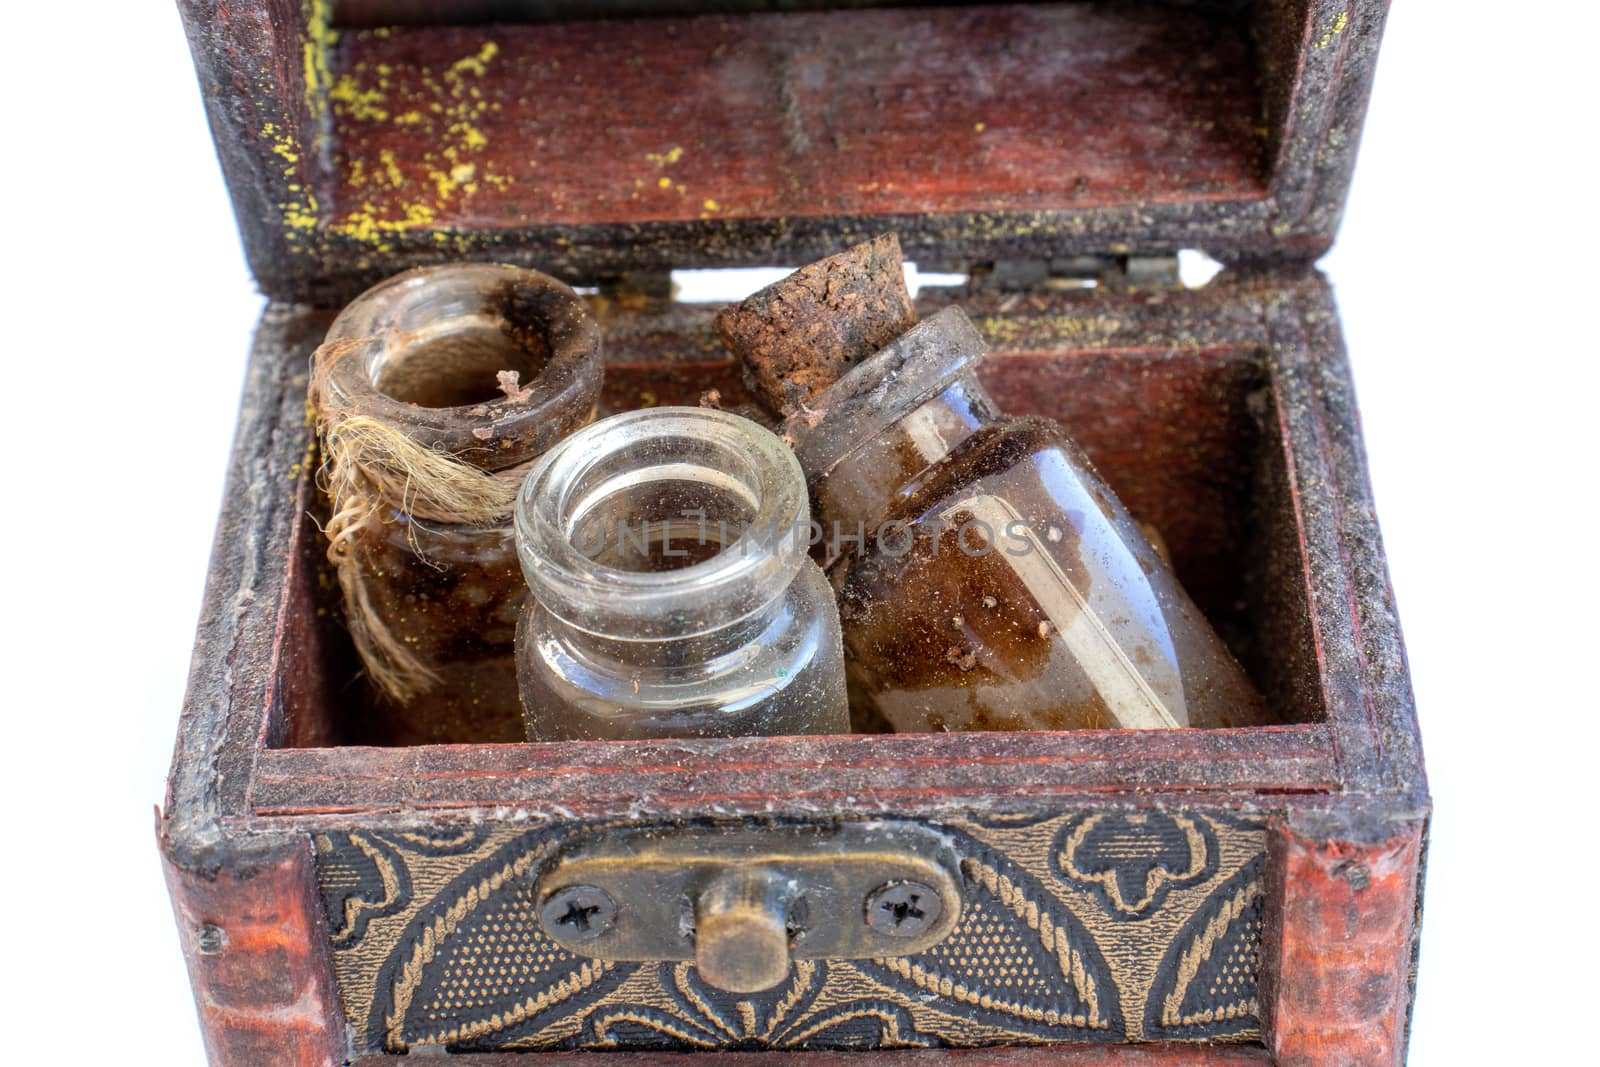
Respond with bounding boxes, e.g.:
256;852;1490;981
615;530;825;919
0;0;1600;1065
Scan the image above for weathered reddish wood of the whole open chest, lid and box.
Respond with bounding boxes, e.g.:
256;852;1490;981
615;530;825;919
160;0;1429;1049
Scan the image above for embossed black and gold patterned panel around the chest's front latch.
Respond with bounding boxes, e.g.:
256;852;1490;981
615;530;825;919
317;809;1266;1051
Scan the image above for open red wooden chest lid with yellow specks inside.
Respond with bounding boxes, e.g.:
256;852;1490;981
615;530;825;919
181;0;1387;304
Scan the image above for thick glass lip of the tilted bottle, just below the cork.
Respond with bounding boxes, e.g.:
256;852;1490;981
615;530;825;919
784;307;989;480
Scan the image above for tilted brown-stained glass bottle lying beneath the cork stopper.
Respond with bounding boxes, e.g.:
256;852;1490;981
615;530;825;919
786;307;1267;731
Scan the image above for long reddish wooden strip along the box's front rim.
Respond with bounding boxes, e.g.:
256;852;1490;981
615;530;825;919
251;725;1338;817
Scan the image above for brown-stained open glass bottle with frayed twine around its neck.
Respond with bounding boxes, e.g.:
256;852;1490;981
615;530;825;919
312;264;603;744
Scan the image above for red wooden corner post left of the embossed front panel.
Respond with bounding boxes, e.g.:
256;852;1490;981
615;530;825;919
165;838;349;1067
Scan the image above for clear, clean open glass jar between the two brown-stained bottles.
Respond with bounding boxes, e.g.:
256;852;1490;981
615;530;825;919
517;408;850;741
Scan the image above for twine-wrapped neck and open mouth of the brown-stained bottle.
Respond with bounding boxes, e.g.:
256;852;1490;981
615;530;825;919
309;262;605;705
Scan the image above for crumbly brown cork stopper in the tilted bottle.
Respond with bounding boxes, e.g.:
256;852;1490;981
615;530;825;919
715;234;917;418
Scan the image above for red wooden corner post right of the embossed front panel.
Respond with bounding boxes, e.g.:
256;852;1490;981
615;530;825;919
1261;821;1424;1067
